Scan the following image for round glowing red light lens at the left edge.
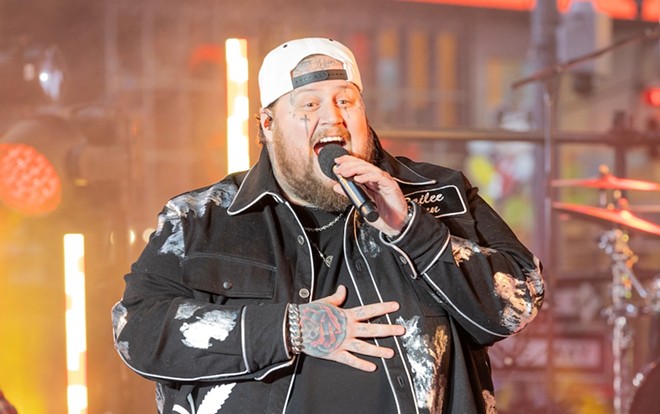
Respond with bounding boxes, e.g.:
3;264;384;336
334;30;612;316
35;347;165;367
0;143;62;216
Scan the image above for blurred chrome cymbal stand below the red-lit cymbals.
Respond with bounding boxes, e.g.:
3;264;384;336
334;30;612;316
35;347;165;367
598;229;647;414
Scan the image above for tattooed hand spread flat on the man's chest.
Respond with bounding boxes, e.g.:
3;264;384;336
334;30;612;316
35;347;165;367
300;285;405;371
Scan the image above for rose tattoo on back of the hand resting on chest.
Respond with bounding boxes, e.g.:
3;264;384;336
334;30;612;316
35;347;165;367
300;303;346;356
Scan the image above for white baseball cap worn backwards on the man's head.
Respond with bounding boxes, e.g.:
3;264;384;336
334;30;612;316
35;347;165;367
259;37;362;108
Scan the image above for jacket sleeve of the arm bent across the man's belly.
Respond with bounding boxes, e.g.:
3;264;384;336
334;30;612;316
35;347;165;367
112;205;292;381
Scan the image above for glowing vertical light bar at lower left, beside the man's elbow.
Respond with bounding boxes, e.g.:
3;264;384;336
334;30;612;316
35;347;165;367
64;234;87;414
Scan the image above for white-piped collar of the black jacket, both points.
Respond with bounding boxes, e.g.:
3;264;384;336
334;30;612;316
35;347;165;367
227;137;436;215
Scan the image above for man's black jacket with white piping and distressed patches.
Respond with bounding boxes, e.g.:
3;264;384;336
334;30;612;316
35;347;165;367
113;144;543;414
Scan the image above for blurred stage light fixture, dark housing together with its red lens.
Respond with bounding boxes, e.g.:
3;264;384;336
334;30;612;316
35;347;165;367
0;108;131;216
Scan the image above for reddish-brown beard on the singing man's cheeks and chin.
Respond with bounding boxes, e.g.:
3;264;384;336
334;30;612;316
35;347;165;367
271;128;375;212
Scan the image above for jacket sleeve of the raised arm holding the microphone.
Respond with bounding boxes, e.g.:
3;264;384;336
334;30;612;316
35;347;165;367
384;177;544;345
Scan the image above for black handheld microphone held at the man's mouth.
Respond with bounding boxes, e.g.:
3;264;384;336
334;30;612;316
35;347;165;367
319;144;379;223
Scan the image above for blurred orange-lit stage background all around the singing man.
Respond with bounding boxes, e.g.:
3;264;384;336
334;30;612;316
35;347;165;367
0;0;660;414
